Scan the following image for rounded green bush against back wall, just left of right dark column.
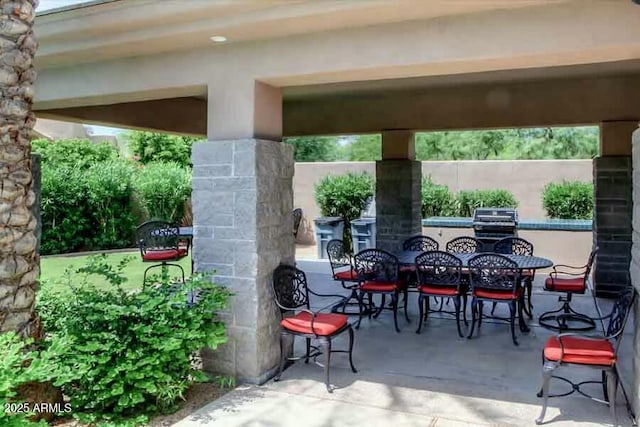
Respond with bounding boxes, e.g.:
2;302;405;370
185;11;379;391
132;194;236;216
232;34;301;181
542;181;593;219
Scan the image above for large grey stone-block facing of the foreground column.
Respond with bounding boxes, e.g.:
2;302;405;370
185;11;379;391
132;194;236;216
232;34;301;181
192;139;295;383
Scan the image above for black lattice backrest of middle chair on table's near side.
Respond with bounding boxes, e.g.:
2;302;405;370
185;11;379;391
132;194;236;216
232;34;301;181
416;251;462;287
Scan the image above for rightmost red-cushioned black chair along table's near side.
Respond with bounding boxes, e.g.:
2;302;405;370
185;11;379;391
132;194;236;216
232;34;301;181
467;253;522;345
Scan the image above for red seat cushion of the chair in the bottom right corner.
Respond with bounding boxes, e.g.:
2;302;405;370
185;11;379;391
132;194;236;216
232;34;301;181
544;337;616;366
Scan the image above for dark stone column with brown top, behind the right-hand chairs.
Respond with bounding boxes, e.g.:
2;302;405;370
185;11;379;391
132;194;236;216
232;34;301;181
593;121;637;297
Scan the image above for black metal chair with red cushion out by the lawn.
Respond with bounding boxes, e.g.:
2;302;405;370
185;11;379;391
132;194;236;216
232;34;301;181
136;220;190;286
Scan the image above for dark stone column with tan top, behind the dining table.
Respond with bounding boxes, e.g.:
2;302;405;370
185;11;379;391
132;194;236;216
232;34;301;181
376;130;422;252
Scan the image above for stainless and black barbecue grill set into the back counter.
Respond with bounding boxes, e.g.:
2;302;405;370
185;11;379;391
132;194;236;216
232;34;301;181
473;208;518;252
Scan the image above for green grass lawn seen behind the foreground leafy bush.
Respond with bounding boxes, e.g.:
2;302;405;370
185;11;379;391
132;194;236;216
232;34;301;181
40;250;191;289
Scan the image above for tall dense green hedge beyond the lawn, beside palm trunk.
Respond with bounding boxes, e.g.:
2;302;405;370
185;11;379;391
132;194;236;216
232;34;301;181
33;140;191;255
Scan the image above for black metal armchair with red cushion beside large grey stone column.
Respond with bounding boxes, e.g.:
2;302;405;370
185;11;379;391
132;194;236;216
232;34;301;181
272;265;357;393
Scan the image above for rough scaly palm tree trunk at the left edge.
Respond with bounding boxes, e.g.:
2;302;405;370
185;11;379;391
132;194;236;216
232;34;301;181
0;0;62;419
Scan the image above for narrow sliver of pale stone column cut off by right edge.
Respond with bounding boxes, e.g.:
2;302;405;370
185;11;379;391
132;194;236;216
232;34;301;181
628;124;640;422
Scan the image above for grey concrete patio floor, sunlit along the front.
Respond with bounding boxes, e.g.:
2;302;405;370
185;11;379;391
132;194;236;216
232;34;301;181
175;261;632;427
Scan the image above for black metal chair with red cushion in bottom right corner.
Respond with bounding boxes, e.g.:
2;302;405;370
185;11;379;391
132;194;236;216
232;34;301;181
536;289;636;426
